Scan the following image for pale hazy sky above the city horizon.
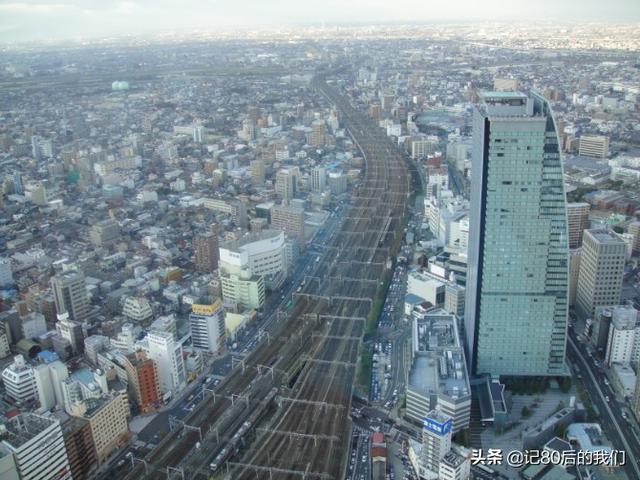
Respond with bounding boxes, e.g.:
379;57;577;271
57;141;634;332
0;0;640;42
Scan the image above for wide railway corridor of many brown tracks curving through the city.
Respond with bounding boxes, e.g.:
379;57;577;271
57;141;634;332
120;68;410;480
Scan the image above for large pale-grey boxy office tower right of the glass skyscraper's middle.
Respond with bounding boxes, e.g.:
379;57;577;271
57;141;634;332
576;229;627;318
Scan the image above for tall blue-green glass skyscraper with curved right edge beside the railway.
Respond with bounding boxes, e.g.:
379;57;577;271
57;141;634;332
465;92;568;376
